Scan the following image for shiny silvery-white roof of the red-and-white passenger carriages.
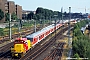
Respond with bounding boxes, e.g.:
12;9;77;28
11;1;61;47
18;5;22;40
26;24;54;38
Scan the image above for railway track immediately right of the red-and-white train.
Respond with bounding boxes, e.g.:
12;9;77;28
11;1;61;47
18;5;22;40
19;27;68;60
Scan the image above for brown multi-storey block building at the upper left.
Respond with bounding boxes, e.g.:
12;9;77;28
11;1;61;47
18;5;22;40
0;0;22;22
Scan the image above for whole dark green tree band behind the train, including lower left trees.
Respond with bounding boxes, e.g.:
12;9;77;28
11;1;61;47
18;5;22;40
27;7;64;20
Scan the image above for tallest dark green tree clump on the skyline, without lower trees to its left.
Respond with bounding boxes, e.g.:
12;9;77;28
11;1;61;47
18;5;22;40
34;7;60;20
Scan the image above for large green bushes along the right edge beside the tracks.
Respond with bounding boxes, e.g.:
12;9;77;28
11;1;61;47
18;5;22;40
72;20;90;58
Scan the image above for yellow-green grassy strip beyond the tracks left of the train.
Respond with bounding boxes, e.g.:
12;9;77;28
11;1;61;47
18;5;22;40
1;20;49;37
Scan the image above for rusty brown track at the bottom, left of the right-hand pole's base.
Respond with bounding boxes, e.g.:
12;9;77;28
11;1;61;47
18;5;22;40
44;43;65;60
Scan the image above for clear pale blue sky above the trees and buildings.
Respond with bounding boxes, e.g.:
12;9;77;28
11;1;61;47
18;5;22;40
9;0;90;13
